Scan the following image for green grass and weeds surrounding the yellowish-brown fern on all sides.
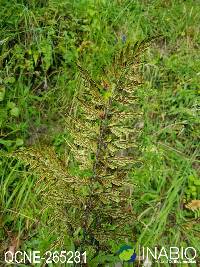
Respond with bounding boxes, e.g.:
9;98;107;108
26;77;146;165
0;0;200;266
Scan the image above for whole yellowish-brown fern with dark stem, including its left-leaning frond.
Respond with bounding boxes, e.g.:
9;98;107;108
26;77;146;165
1;41;152;260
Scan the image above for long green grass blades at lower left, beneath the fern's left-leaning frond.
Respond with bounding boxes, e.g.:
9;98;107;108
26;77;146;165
0;157;40;264
